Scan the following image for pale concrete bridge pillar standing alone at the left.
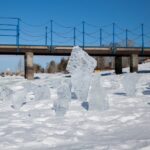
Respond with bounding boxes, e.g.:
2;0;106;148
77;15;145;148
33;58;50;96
24;52;34;80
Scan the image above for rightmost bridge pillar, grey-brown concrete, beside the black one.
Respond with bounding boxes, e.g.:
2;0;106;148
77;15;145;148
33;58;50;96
130;54;138;72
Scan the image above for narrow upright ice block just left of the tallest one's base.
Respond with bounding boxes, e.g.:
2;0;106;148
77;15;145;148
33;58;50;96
53;81;71;116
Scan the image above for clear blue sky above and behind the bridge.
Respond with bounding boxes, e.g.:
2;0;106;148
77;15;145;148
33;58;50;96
0;0;150;71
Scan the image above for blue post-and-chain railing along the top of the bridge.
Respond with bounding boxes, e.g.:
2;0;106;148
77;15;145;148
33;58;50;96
0;17;150;52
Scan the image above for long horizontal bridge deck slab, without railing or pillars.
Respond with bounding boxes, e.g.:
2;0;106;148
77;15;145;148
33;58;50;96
0;45;150;57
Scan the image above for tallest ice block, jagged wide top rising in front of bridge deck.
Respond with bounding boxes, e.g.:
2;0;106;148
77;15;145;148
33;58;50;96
67;46;97;102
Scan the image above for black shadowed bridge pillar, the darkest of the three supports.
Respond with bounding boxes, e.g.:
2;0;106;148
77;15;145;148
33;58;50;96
115;56;122;74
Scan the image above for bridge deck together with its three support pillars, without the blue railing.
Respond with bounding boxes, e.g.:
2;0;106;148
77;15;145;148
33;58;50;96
0;45;150;80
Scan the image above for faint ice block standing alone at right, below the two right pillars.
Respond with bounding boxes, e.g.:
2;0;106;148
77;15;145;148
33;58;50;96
122;73;139;96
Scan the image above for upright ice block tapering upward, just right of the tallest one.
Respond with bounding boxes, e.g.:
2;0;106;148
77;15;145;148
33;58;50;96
88;73;108;111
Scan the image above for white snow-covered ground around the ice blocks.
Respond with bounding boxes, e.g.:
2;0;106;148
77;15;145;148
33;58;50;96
0;63;150;150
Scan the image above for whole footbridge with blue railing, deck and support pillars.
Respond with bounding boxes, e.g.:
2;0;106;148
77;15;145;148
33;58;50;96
0;17;150;79
